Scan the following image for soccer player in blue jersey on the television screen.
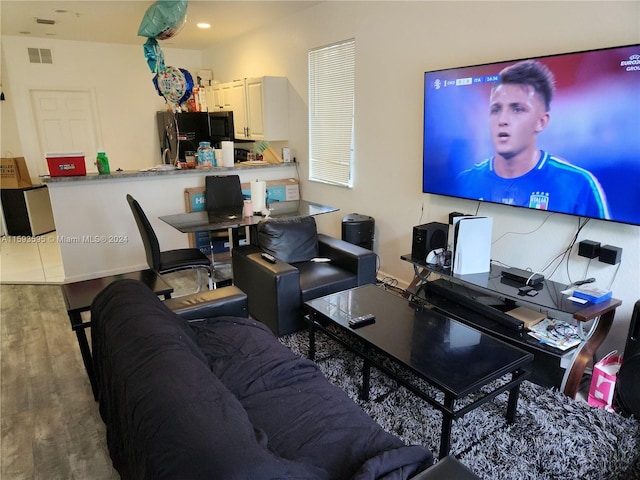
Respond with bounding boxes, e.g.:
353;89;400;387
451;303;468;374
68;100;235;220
458;60;609;219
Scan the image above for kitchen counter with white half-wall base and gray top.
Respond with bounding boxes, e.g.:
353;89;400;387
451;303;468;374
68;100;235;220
43;163;297;283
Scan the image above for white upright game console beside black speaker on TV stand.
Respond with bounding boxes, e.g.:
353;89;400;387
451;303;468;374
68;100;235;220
453;217;493;275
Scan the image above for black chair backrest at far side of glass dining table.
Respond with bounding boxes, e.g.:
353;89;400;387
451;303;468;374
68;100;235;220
205;175;244;225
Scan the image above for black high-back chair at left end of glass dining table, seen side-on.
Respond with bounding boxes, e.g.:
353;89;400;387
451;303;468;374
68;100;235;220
127;194;214;291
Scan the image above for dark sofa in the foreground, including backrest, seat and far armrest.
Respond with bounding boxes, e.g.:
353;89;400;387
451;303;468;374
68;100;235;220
91;280;433;480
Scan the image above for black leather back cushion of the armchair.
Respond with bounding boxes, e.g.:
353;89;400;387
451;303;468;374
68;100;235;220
257;217;318;263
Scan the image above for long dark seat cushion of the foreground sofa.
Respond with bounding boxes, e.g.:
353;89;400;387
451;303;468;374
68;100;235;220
192;317;432;480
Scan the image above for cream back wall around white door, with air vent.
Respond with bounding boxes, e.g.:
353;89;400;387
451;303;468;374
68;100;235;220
0;36;202;176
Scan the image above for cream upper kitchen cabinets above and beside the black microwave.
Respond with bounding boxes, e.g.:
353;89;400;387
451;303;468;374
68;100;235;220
207;77;289;141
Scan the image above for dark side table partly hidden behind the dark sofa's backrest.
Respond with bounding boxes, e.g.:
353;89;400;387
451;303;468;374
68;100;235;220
62;270;173;400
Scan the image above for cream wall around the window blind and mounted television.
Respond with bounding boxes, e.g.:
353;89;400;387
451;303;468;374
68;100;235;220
204;1;640;351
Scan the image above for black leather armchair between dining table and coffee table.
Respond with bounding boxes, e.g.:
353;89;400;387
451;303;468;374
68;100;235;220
231;217;377;336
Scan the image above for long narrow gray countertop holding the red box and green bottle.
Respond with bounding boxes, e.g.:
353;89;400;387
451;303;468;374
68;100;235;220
42;162;294;184
